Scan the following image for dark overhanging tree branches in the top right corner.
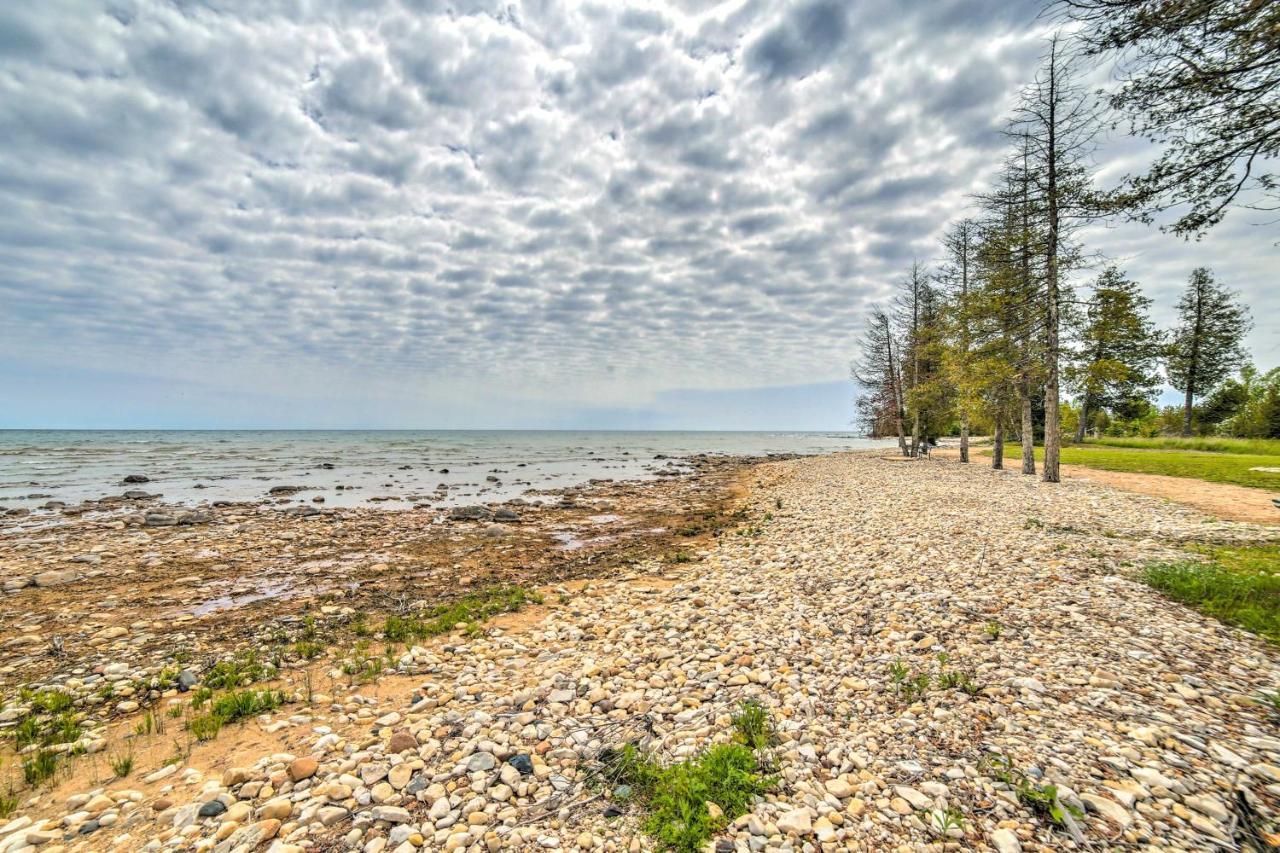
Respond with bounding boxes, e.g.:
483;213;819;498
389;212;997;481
1056;0;1280;237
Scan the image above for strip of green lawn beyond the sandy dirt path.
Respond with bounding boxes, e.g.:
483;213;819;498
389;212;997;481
1005;439;1280;491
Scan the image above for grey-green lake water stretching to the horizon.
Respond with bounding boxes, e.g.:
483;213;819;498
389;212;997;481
0;430;891;508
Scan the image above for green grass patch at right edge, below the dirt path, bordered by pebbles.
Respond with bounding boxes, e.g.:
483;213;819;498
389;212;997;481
1143;546;1280;643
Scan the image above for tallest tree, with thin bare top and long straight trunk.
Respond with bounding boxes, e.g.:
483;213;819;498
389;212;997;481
1009;36;1098;483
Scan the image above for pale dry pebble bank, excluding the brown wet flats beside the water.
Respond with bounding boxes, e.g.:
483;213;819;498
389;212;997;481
0;451;1280;853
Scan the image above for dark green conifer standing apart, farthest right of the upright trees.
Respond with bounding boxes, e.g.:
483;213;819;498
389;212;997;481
1165;266;1253;435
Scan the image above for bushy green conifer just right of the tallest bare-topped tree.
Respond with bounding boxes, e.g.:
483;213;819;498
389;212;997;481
1068;266;1161;442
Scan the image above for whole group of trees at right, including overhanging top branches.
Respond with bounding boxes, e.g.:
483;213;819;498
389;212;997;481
852;0;1280;482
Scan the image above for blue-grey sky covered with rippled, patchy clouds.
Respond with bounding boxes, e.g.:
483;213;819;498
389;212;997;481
0;0;1280;429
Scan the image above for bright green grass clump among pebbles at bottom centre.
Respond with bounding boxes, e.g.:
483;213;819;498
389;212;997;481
602;702;777;853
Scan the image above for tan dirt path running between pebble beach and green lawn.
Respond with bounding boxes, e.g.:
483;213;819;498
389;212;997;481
933;447;1280;525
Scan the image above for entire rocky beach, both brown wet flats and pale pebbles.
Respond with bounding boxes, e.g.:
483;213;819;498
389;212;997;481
0;452;1280;853
